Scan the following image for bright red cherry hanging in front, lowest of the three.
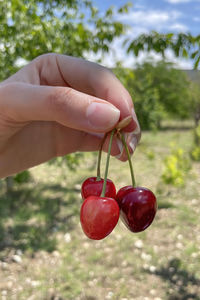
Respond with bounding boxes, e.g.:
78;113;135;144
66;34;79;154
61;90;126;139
80;196;119;240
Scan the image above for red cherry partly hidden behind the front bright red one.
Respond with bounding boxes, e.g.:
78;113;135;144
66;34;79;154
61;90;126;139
81;177;116;199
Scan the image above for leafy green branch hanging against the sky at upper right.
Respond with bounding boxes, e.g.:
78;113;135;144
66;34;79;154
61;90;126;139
125;31;200;68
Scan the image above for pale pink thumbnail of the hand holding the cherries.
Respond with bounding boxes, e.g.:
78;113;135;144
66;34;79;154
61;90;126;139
86;102;120;130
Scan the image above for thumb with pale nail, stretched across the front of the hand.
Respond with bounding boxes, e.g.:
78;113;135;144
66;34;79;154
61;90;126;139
0;83;120;132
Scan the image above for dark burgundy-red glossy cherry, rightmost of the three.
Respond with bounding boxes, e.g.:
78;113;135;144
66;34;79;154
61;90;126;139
116;186;157;232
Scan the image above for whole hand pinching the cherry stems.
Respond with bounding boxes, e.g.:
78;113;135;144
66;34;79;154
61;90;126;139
0;54;140;178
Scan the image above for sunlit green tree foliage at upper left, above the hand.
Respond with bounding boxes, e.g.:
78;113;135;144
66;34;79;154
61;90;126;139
0;0;130;80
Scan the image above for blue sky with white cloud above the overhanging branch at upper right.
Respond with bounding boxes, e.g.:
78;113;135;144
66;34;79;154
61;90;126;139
93;0;200;35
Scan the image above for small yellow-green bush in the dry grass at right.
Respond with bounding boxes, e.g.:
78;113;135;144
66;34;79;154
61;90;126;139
162;147;191;186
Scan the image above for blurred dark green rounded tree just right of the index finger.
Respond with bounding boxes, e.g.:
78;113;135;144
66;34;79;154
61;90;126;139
114;61;192;129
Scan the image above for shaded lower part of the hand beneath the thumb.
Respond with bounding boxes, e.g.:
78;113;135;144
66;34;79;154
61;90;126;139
0;121;119;178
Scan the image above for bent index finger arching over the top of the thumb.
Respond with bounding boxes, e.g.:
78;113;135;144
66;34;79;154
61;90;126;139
35;54;138;131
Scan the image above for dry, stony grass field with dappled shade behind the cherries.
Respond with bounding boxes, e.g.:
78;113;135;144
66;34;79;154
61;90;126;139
0;122;200;300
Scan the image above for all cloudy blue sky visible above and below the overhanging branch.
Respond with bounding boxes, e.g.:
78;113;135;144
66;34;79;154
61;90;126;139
88;0;200;69
